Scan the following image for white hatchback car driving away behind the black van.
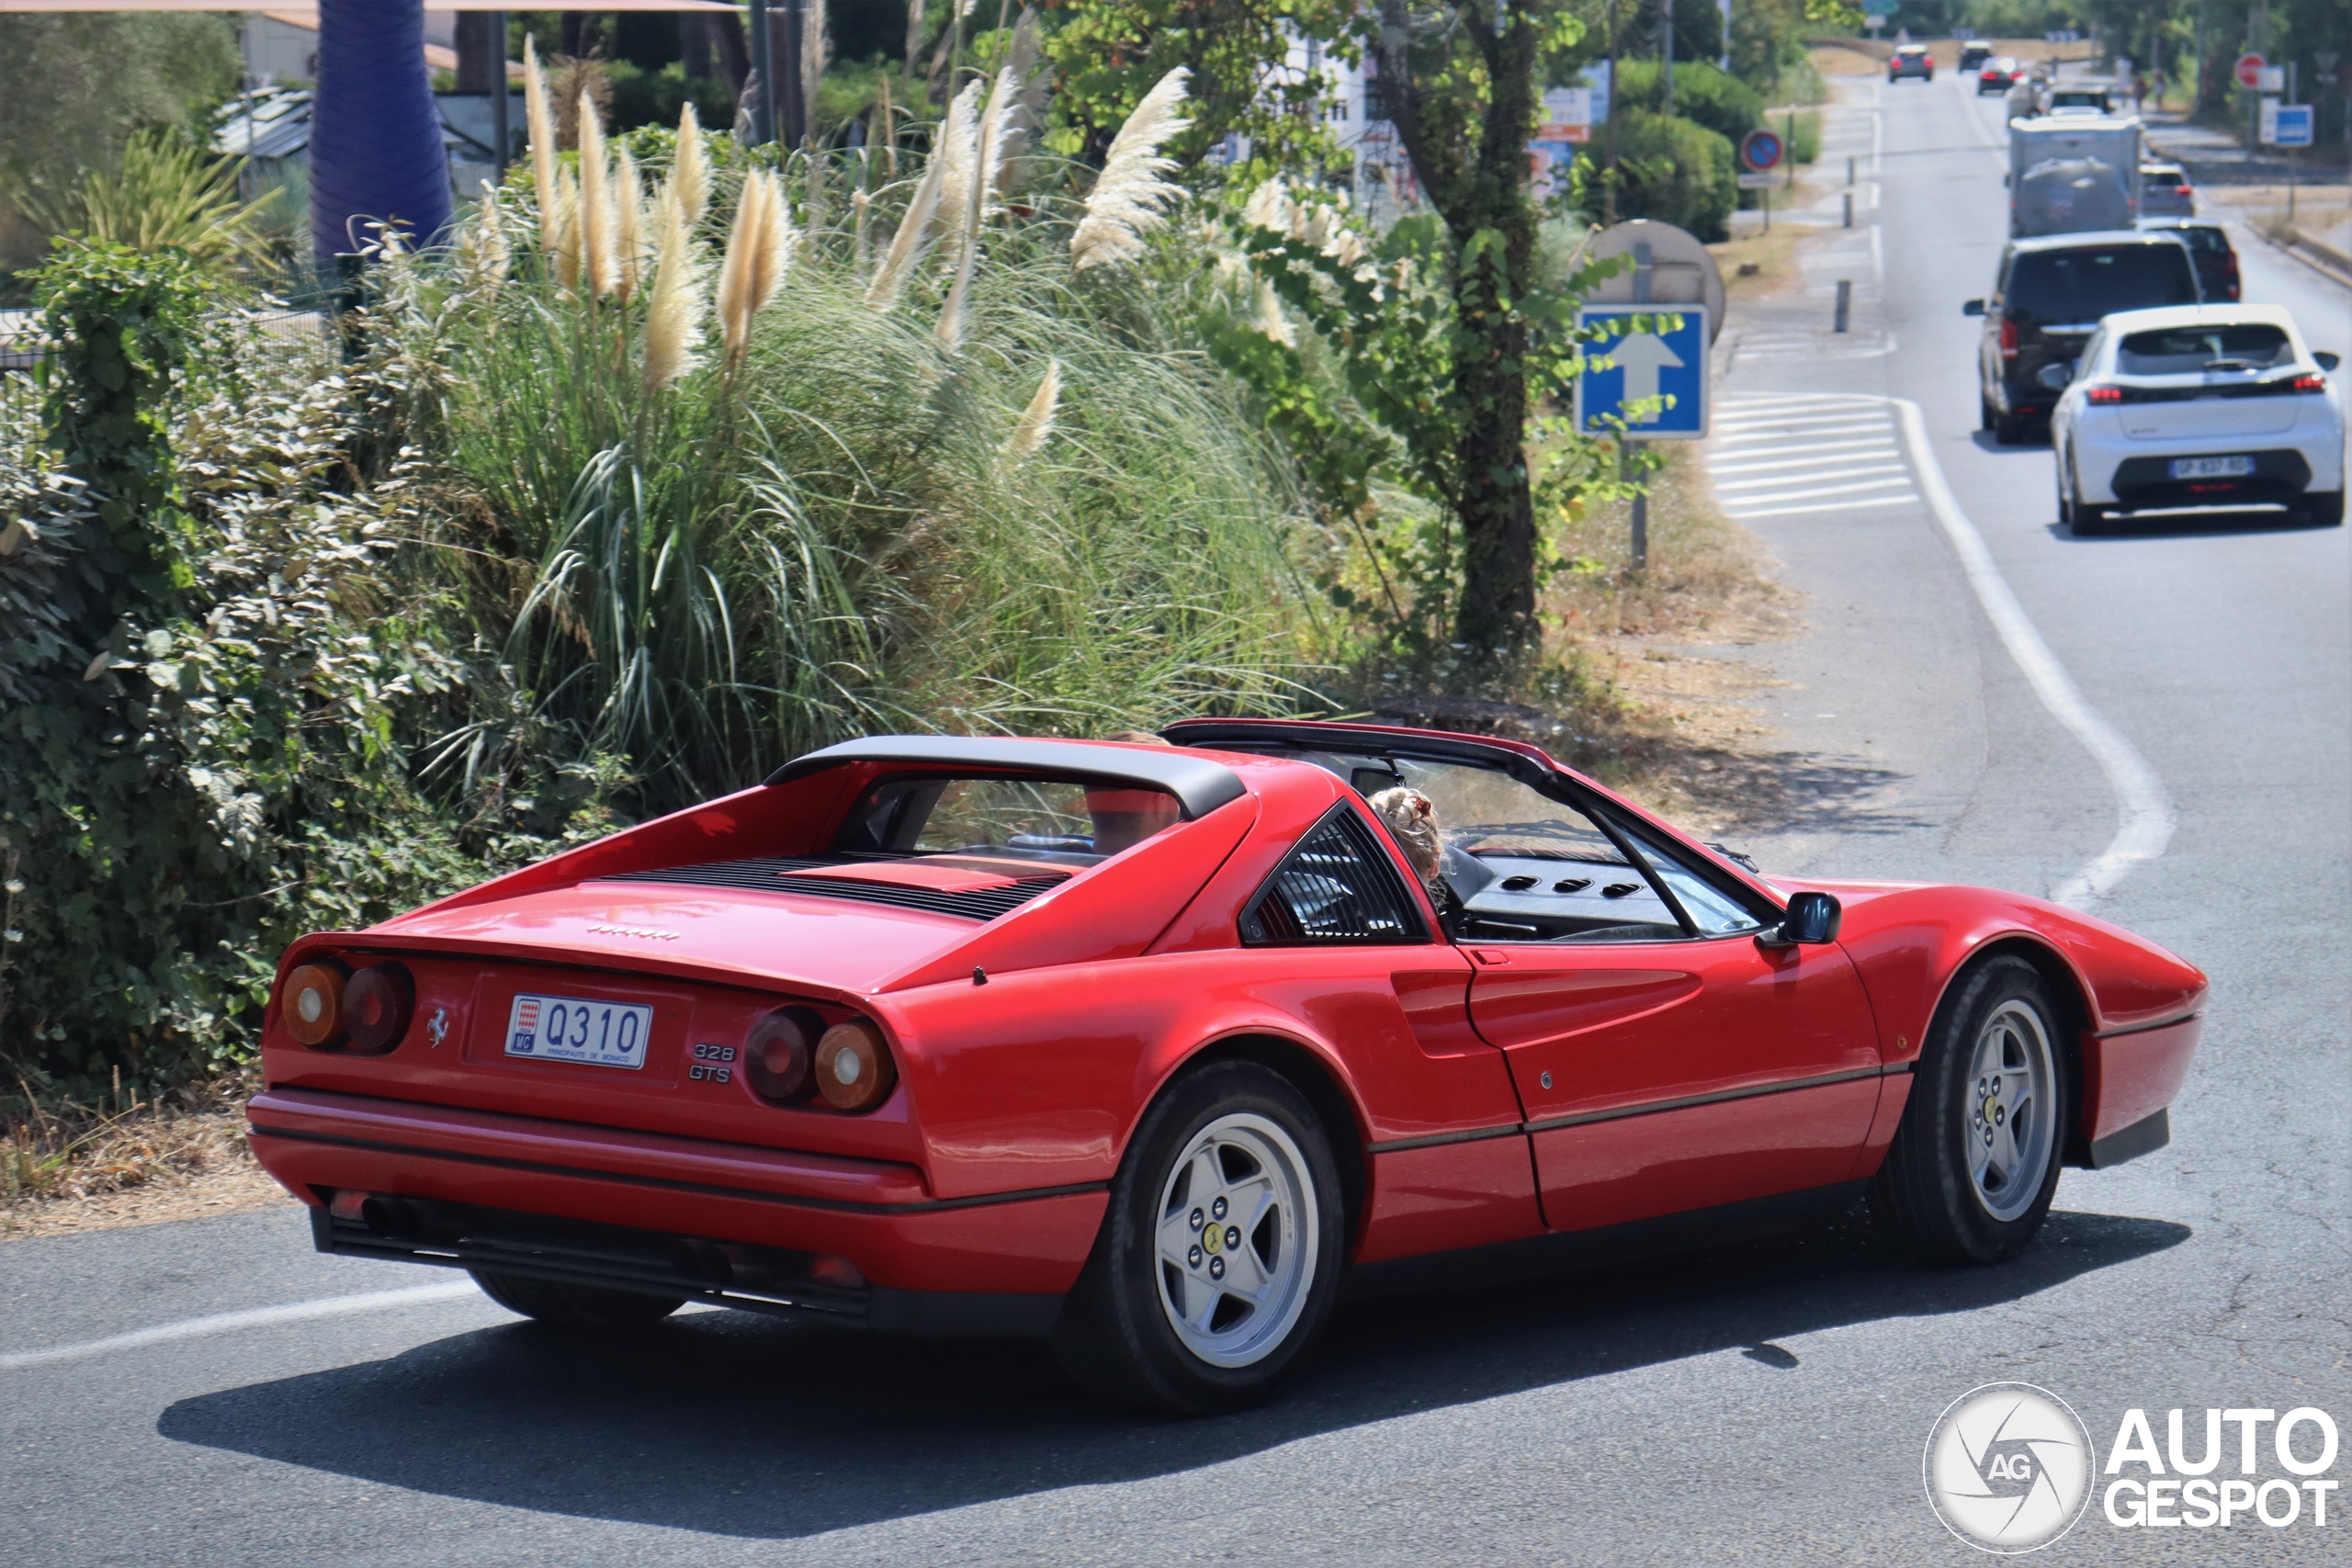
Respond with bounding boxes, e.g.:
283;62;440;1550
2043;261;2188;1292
2041;306;2345;534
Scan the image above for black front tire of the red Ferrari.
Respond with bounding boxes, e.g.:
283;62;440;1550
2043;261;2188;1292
1870;957;2075;1262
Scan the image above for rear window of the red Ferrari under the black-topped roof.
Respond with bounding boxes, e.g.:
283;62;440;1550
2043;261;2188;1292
832;773;1183;865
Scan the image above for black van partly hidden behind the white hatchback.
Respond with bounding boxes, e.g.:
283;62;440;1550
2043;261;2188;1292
1962;231;2204;442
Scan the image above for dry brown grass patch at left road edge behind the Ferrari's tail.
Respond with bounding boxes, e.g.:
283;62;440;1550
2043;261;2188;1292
0;1079;291;1241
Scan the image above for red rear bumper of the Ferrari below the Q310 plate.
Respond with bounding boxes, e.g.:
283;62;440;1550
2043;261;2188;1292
247;1089;1108;1316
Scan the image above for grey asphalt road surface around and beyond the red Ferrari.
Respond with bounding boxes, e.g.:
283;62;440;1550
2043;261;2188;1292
0;80;2352;1565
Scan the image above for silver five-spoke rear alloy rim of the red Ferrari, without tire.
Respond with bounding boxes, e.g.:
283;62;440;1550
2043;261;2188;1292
1159;1112;1322;1366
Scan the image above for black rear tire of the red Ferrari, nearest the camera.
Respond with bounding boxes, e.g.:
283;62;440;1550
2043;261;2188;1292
1054;1063;1348;1416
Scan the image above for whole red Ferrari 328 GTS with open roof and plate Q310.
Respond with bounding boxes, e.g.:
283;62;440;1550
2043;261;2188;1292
252;719;2206;1411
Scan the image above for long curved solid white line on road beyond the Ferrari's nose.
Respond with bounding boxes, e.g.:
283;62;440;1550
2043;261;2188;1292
1886;398;2176;909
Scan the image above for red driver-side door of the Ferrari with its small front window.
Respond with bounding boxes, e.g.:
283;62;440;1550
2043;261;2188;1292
1463;823;1879;1232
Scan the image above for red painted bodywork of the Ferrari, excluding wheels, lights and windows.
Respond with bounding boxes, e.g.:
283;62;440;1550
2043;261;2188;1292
249;722;2204;1325
